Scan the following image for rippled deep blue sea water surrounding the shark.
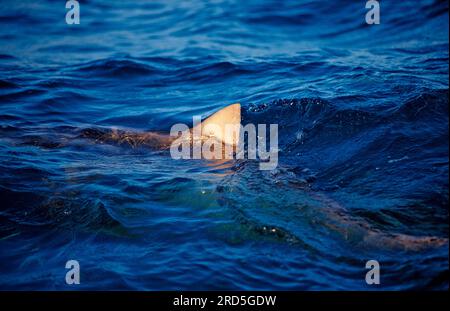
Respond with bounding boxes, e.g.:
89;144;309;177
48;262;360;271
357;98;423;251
0;0;449;290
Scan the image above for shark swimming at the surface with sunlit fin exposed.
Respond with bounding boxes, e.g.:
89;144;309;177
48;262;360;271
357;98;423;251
78;103;448;251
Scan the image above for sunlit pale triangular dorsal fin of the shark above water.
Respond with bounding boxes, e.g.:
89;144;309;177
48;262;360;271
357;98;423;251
195;103;241;146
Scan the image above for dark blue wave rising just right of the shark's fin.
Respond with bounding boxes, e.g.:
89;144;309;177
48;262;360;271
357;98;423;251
243;89;448;162
